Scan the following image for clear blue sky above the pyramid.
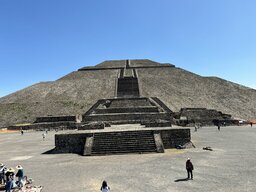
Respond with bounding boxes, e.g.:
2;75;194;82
0;0;256;97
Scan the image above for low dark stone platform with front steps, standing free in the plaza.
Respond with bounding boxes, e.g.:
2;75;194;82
52;125;191;156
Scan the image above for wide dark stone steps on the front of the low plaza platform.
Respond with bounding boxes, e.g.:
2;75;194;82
91;130;157;155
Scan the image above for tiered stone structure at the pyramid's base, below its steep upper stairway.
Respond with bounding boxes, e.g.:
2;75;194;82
82;97;172;124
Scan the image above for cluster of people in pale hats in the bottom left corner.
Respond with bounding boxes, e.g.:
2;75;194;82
0;163;25;192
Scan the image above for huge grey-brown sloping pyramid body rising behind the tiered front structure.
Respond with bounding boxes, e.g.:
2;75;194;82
0;59;256;127
